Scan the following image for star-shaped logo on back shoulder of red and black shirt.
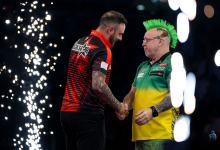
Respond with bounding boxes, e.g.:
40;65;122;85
72;40;90;58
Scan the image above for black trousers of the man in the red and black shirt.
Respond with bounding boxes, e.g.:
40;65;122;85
60;111;106;150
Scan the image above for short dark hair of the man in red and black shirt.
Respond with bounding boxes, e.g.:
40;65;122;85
99;10;127;26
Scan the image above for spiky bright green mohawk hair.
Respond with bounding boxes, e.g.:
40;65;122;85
143;19;177;48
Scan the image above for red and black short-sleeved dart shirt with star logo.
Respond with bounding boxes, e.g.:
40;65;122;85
61;30;112;114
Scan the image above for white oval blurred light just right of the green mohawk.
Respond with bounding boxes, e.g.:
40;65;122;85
177;13;189;43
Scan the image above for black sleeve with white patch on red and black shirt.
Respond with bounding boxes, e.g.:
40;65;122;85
91;48;110;75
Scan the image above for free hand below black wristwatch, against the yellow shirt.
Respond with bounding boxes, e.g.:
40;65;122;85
134;108;153;125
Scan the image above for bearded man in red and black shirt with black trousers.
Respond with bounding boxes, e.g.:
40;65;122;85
60;11;128;150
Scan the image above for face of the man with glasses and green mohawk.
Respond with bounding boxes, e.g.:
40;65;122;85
142;29;160;59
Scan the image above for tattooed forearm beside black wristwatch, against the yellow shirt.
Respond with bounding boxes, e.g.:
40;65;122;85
155;96;173;113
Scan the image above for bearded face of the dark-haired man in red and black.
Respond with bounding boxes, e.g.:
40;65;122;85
109;23;125;47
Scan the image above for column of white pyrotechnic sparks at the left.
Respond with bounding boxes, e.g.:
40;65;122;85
0;1;61;150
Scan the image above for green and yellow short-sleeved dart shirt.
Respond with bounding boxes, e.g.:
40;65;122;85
132;52;179;141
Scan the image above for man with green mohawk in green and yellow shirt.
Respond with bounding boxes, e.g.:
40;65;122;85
116;19;179;150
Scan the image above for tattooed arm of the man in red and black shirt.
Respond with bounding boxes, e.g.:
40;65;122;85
92;71;121;110
